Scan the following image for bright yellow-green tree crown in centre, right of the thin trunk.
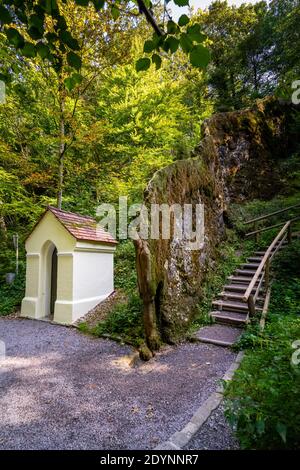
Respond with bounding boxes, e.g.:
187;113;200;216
82;55;205;202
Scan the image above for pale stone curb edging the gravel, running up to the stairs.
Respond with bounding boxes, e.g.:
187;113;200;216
154;351;244;450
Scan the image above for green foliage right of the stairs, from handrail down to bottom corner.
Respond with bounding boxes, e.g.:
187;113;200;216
226;241;300;449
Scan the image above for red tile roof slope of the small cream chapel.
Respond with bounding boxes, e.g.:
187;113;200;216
47;206;118;245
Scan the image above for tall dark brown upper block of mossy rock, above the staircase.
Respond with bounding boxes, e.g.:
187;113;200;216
195;98;299;203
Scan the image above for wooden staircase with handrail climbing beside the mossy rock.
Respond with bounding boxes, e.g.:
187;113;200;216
194;218;298;346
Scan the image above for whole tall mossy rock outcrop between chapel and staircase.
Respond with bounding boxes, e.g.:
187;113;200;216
135;98;295;349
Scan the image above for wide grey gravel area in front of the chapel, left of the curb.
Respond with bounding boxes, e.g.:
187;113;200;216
0;318;235;449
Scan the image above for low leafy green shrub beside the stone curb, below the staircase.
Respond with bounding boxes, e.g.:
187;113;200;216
226;315;300;449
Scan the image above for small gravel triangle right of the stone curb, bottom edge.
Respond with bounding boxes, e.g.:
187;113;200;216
184;404;239;450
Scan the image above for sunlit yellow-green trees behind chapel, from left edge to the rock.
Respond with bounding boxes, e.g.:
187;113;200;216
0;12;206;282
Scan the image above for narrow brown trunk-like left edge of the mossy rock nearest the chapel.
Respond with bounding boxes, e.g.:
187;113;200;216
134;239;161;351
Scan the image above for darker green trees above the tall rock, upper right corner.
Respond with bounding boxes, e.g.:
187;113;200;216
195;0;300;111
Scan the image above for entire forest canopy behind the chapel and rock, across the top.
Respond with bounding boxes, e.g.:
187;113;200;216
0;0;300;279
